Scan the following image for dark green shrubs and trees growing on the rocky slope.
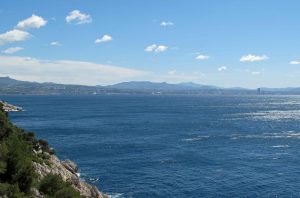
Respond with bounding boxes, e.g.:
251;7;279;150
0;104;81;198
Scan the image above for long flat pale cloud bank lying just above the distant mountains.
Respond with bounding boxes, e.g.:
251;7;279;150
0;56;149;85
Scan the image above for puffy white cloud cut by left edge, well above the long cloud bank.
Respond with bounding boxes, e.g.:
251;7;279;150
0;30;30;45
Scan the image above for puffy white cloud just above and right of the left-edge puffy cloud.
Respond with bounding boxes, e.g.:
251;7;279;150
16;14;47;30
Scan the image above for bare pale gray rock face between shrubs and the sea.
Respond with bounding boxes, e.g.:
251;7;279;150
33;155;108;198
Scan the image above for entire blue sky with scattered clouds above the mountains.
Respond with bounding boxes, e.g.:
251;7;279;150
0;0;300;88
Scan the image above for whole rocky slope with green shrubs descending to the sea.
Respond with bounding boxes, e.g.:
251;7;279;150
0;103;105;198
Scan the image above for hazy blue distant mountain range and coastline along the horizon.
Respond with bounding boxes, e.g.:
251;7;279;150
0;77;300;95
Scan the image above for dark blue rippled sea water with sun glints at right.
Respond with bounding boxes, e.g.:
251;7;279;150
1;96;300;198
